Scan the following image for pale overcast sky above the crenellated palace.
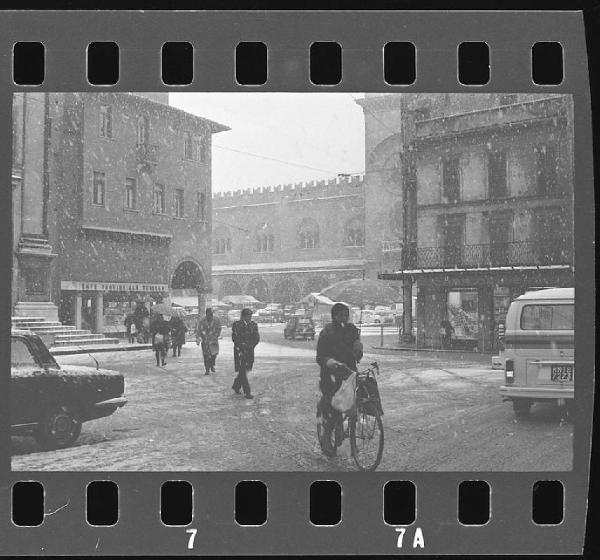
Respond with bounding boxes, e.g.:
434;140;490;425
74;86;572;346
169;93;365;192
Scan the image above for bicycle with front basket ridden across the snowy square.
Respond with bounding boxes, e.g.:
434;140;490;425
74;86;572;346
317;362;384;471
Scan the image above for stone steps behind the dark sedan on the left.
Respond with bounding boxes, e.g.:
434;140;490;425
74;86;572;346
12;317;119;348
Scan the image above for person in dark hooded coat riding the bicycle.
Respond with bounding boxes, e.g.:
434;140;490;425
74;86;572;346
317;303;363;446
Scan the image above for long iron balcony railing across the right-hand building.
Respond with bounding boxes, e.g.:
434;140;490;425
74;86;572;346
382;240;573;270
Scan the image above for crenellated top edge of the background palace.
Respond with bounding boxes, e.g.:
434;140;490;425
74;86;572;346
212;174;364;208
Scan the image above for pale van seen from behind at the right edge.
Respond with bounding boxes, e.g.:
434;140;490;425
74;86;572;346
500;288;575;418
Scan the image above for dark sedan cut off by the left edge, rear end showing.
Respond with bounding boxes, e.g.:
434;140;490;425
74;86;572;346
10;329;127;449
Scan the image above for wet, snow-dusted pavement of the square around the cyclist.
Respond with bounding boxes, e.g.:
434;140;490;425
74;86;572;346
12;327;573;471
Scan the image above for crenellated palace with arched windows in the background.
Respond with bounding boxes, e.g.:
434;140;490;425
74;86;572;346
212;176;366;304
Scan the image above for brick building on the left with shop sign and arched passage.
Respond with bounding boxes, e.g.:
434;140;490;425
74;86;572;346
13;92;227;332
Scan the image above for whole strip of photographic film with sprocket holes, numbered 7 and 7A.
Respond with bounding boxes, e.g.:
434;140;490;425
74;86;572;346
0;8;595;555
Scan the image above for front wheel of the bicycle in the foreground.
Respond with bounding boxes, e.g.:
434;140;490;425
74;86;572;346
350;401;383;471
